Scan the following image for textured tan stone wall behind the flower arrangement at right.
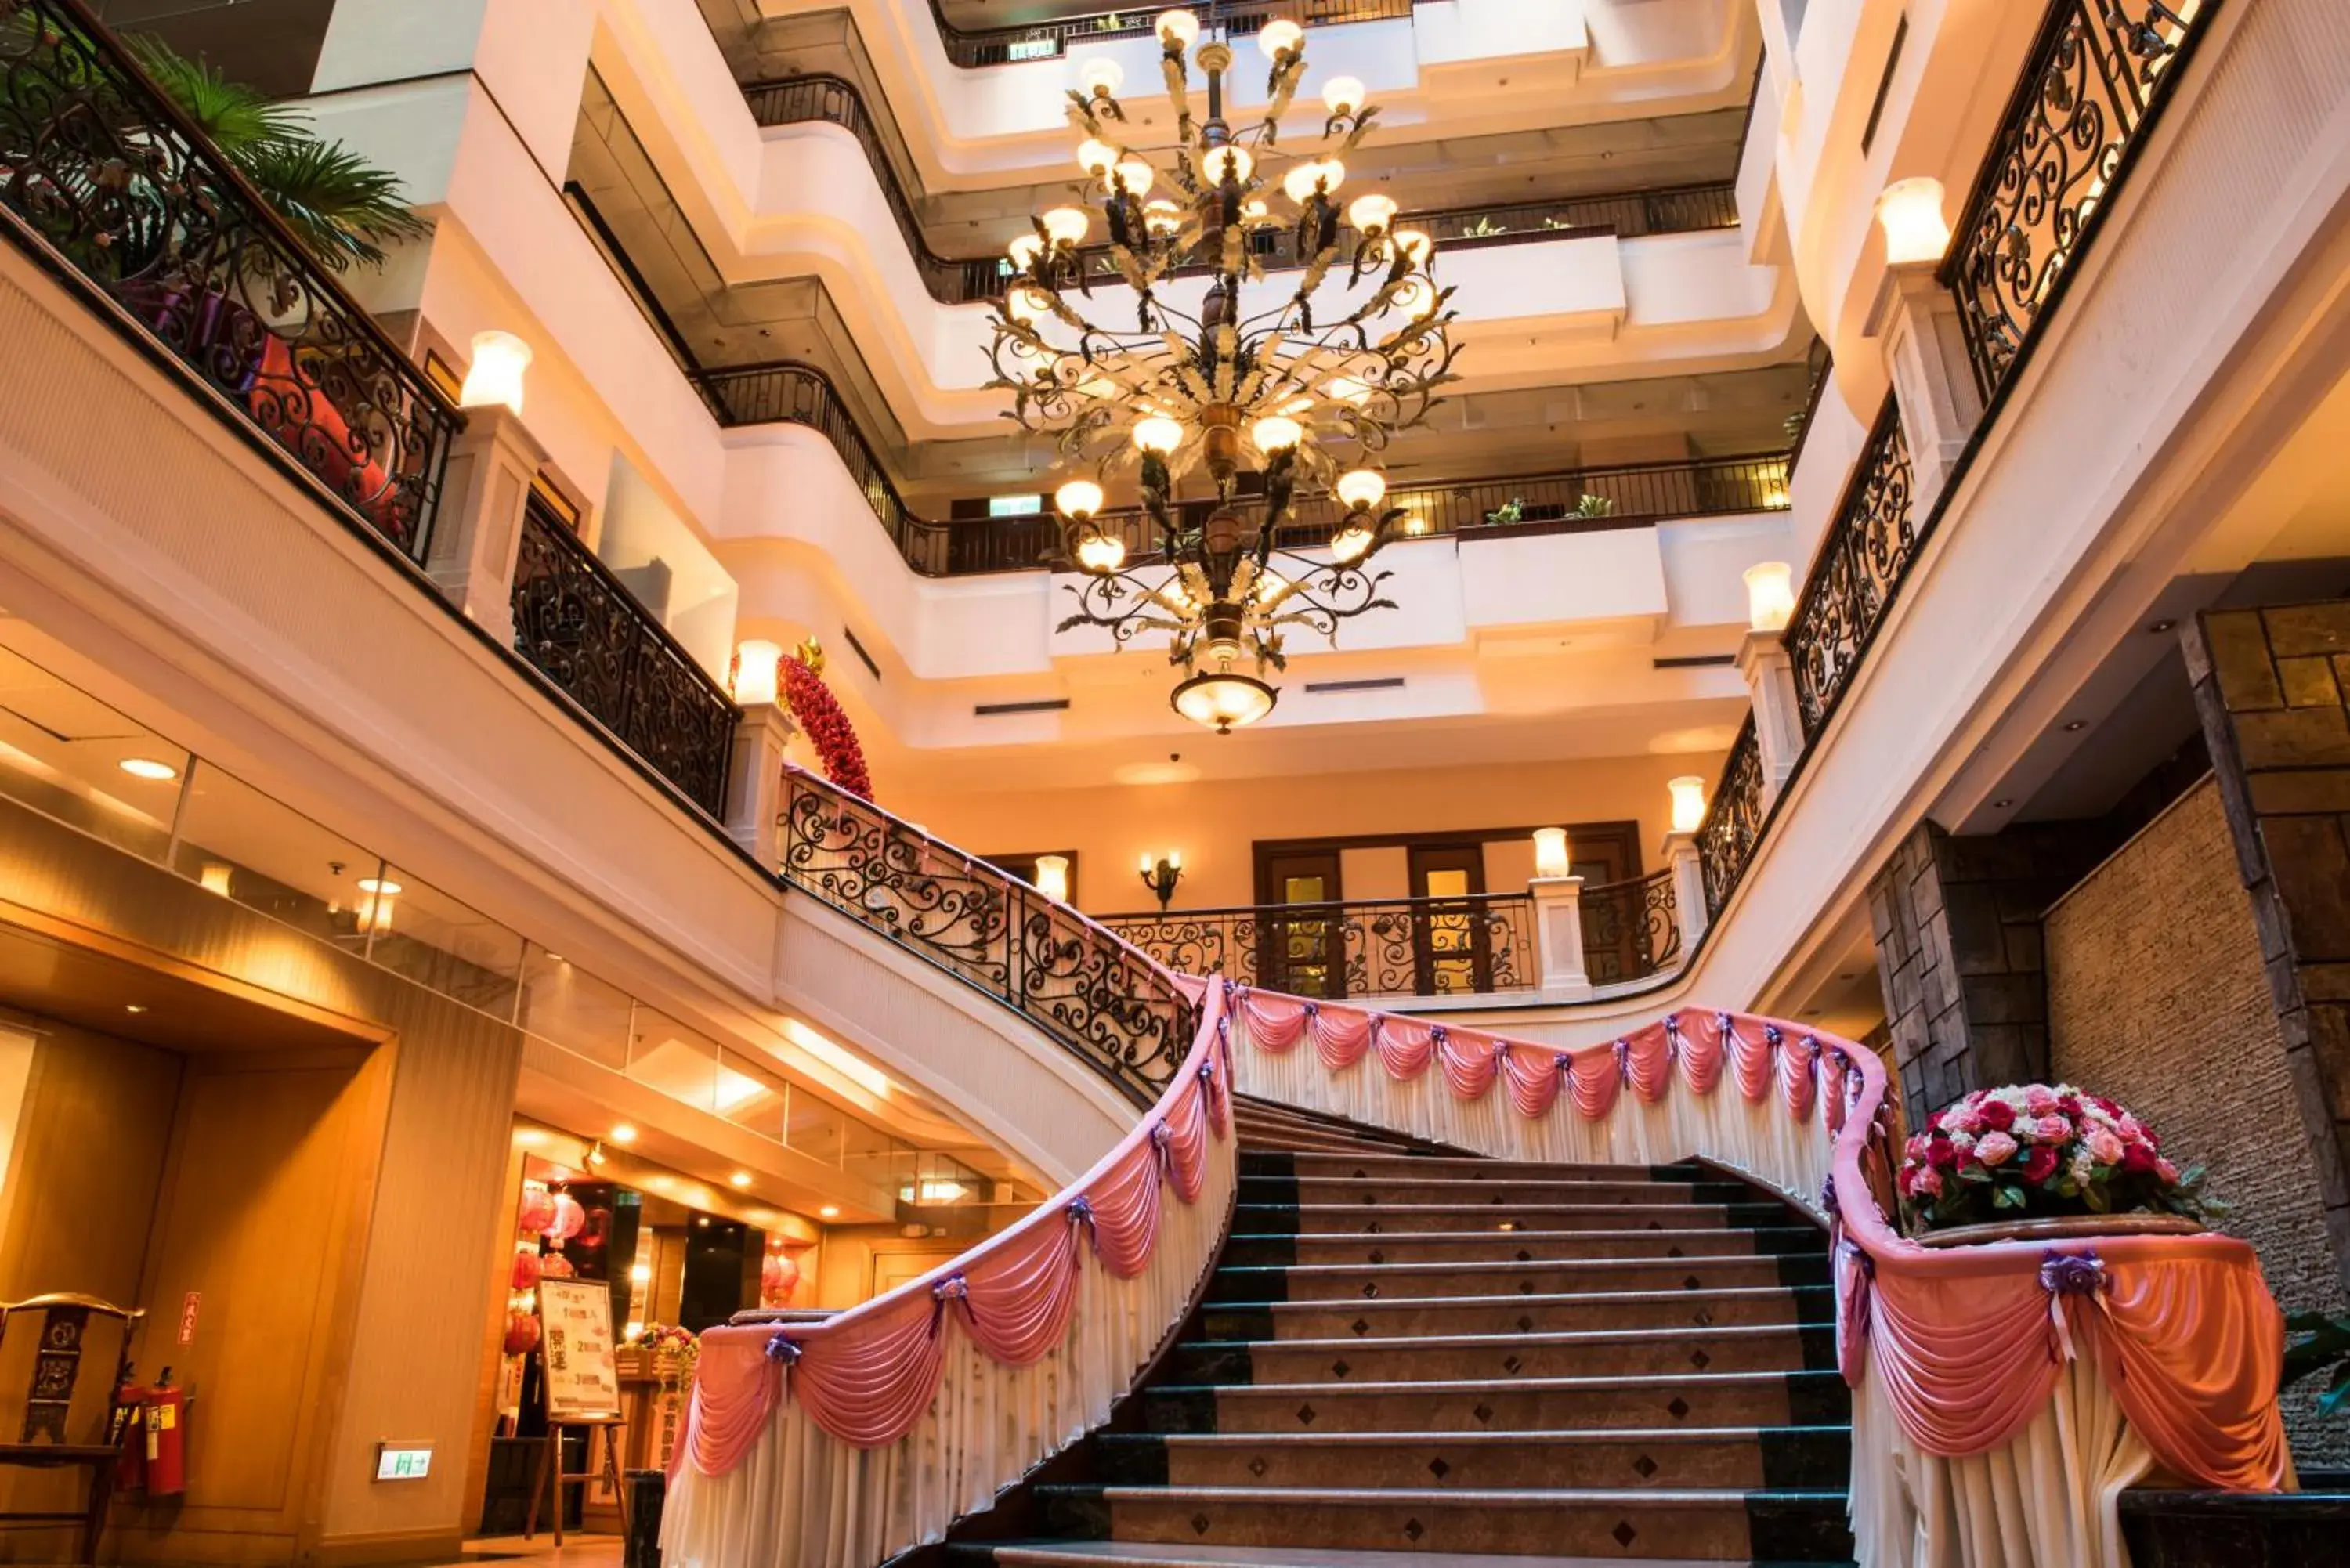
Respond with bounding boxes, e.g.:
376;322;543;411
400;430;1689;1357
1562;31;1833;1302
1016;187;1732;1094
2047;778;2350;1465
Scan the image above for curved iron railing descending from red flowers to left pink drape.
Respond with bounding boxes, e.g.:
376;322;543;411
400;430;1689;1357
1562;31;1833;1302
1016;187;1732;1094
783;768;1194;1105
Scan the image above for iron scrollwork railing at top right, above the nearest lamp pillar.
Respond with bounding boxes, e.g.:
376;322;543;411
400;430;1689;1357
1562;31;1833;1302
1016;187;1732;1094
1943;0;2218;402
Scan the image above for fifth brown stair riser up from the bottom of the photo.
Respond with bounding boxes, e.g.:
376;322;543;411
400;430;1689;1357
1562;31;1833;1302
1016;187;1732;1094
1201;1286;1835;1340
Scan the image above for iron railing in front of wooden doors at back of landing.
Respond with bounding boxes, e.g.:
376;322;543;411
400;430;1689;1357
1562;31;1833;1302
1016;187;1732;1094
1102;894;1542;999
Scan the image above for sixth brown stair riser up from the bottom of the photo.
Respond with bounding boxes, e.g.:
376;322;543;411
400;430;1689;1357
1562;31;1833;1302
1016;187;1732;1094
1208;1255;1828;1302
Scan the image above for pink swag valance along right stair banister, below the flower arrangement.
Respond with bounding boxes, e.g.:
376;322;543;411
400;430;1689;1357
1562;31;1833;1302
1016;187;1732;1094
1236;990;2287;1490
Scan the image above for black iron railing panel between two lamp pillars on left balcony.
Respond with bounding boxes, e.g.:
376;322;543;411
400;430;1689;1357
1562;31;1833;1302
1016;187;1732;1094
515;503;740;818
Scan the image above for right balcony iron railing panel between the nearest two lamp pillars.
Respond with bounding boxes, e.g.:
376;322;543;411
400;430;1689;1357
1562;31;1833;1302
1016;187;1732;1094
1784;392;1925;740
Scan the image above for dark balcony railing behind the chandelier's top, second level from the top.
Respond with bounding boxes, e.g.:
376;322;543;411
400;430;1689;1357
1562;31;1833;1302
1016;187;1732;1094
743;74;1739;305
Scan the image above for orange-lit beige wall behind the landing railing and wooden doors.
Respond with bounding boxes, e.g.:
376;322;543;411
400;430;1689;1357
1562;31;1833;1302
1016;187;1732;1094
881;752;1723;915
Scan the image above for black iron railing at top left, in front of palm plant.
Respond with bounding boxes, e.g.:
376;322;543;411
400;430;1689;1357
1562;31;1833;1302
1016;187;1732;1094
0;0;463;562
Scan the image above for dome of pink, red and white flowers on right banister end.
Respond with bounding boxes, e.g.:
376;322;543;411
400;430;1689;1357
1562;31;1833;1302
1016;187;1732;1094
1896;1084;2223;1230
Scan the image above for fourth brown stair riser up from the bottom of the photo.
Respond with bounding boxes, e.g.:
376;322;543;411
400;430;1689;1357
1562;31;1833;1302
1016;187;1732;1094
1168;1333;1833;1385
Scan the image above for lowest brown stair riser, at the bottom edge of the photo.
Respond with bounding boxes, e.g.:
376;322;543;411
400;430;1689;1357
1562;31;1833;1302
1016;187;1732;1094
1039;1498;1849;1561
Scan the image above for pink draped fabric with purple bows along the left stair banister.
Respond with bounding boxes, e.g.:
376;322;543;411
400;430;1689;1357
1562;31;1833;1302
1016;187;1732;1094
670;985;1231;1476
